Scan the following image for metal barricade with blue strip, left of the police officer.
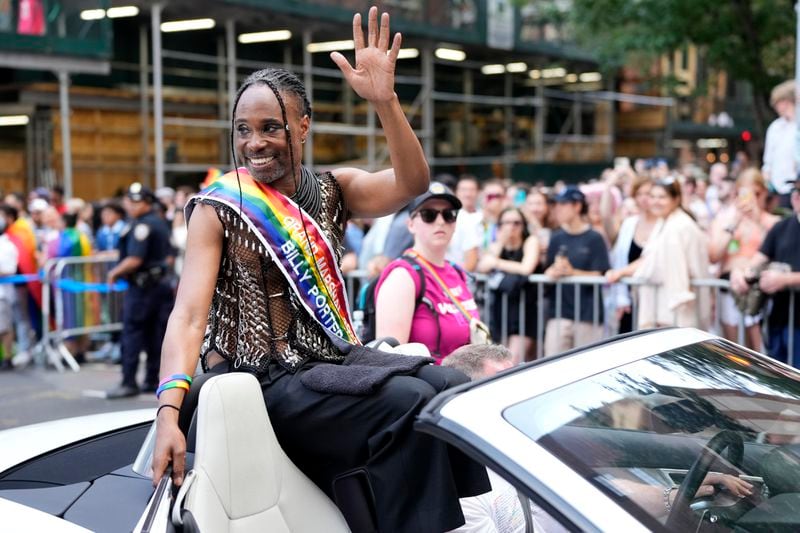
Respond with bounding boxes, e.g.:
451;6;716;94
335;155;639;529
42;255;125;372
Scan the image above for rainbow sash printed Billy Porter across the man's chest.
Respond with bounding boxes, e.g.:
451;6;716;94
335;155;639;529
195;168;361;344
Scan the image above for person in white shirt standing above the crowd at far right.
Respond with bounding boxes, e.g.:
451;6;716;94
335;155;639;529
761;80;797;208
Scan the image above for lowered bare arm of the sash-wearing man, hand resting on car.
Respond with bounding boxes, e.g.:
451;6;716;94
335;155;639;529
153;204;222;485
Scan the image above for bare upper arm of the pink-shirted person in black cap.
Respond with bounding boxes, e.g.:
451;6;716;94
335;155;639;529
375;268;416;344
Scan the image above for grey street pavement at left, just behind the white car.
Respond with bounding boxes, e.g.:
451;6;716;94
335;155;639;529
0;363;156;430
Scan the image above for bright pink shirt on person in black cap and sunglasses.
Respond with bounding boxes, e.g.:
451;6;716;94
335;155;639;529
376;259;479;364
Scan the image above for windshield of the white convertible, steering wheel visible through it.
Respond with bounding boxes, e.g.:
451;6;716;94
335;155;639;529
503;340;800;531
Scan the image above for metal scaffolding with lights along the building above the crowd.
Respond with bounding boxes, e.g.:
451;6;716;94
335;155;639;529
0;2;671;196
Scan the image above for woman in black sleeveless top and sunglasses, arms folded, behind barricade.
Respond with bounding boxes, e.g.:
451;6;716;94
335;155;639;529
478;207;539;365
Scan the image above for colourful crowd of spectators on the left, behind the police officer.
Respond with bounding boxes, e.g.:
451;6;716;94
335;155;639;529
0;186;194;368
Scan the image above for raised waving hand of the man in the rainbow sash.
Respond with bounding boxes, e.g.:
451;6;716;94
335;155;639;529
331;6;402;103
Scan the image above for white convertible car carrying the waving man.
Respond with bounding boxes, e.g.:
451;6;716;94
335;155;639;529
0;329;800;533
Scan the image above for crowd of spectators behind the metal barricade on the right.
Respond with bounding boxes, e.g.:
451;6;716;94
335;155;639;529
354;96;800;370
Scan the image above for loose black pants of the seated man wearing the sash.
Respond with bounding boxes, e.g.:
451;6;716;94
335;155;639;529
250;362;490;533
